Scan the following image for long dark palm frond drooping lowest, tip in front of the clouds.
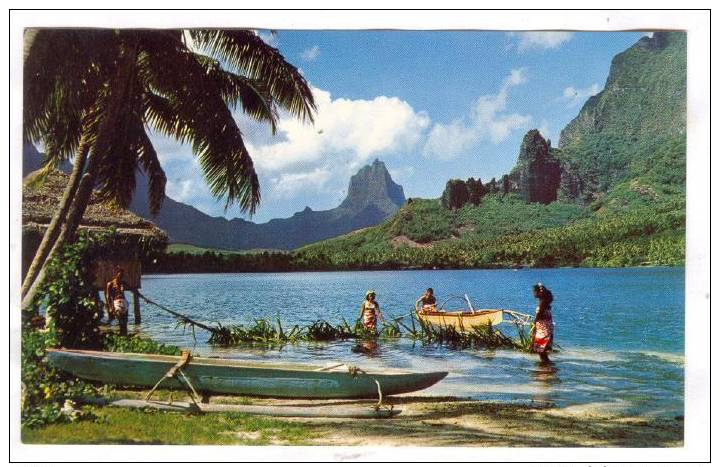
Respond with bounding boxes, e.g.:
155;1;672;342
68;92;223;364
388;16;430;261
138;35;260;214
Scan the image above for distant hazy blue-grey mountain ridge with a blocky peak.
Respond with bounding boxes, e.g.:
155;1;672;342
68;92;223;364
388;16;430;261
130;160;405;250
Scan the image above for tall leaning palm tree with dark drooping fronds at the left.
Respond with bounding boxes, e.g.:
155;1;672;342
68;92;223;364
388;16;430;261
22;29;315;308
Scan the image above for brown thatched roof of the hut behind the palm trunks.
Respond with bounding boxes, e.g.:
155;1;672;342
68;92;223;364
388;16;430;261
22;170;167;247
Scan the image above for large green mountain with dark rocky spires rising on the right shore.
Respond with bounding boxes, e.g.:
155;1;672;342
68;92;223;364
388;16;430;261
295;32;687;269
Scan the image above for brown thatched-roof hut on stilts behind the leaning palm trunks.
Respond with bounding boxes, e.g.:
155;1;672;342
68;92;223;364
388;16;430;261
22;170;167;288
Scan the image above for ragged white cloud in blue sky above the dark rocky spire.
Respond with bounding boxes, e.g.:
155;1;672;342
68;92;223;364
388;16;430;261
423;68;531;160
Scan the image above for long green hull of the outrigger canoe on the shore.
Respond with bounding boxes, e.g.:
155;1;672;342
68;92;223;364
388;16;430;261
48;349;447;399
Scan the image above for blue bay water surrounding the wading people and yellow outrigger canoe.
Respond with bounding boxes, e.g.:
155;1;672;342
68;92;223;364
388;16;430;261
132;268;685;416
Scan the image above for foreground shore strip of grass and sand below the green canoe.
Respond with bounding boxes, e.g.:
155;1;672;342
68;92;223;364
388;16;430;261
22;391;684;447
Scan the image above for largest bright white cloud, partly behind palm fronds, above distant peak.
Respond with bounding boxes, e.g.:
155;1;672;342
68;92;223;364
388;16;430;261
152;88;430;216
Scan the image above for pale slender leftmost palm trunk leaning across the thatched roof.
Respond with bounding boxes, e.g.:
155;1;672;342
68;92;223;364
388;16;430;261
20;137;88;298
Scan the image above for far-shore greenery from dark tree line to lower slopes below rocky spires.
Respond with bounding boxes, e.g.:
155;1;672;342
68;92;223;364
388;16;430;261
143;191;685;272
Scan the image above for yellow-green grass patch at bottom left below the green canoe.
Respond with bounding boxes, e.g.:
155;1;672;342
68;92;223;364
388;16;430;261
21;407;312;445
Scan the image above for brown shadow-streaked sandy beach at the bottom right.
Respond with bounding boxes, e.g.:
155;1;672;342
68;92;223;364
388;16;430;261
232;397;683;447
